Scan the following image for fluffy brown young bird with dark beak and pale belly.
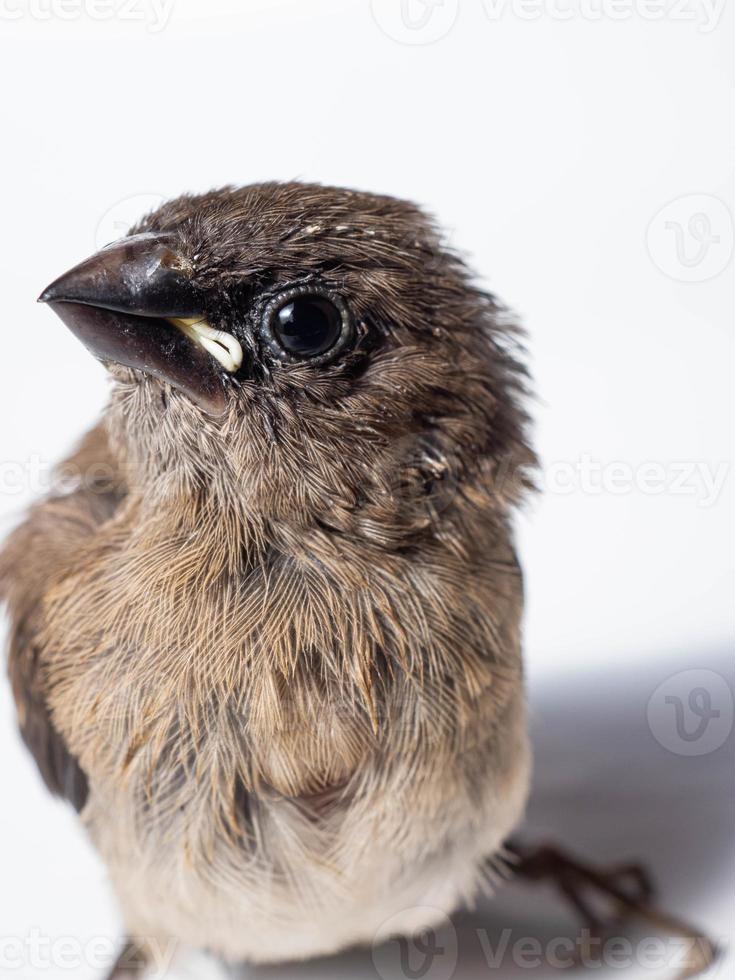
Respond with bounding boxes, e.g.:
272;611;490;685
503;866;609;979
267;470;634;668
0;183;535;975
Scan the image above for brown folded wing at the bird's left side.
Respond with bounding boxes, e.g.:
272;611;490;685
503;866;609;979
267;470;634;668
0;425;125;810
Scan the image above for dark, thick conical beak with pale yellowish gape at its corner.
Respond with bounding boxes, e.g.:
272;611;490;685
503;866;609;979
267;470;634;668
39;233;242;414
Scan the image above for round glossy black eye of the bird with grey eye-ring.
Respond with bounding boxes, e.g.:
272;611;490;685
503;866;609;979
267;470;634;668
263;287;351;363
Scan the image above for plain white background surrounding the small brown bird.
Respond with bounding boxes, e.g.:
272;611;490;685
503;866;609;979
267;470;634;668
0;0;735;980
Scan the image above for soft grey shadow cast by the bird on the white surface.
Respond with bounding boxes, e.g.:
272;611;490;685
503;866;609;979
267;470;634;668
216;650;735;980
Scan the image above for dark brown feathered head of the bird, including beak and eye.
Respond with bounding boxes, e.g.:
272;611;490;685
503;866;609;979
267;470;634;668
41;183;532;544
